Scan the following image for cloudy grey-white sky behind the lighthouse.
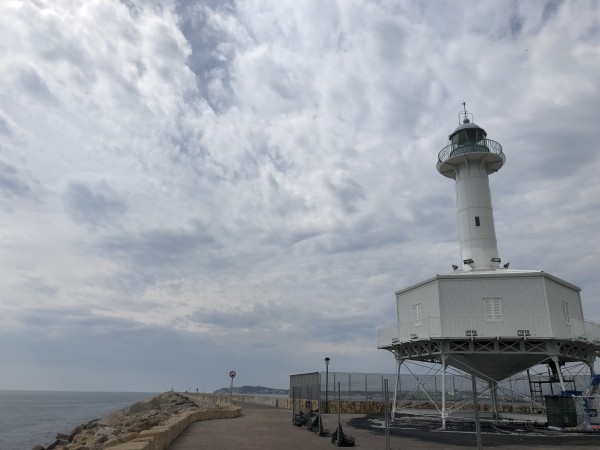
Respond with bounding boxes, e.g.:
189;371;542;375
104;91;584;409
0;0;600;392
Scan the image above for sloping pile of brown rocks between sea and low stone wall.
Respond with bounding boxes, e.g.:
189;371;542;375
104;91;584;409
32;391;229;450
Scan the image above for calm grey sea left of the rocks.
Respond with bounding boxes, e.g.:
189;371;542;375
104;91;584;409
0;390;157;450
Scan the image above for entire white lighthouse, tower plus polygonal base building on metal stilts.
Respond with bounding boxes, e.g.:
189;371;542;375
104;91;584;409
378;110;600;423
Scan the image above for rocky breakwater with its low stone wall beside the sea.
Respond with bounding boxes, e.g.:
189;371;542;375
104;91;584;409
32;392;240;450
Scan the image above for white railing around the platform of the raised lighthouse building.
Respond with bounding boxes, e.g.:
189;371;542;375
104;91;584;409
378;314;600;348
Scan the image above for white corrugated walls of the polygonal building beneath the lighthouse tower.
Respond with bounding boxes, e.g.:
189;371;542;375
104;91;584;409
388;272;586;342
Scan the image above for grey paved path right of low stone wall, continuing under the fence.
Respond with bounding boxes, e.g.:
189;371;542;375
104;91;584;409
169;403;600;450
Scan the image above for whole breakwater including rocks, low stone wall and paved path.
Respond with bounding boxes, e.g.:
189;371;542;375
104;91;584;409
38;392;600;450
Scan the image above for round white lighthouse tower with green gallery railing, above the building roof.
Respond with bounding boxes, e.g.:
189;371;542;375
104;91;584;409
437;103;506;271
